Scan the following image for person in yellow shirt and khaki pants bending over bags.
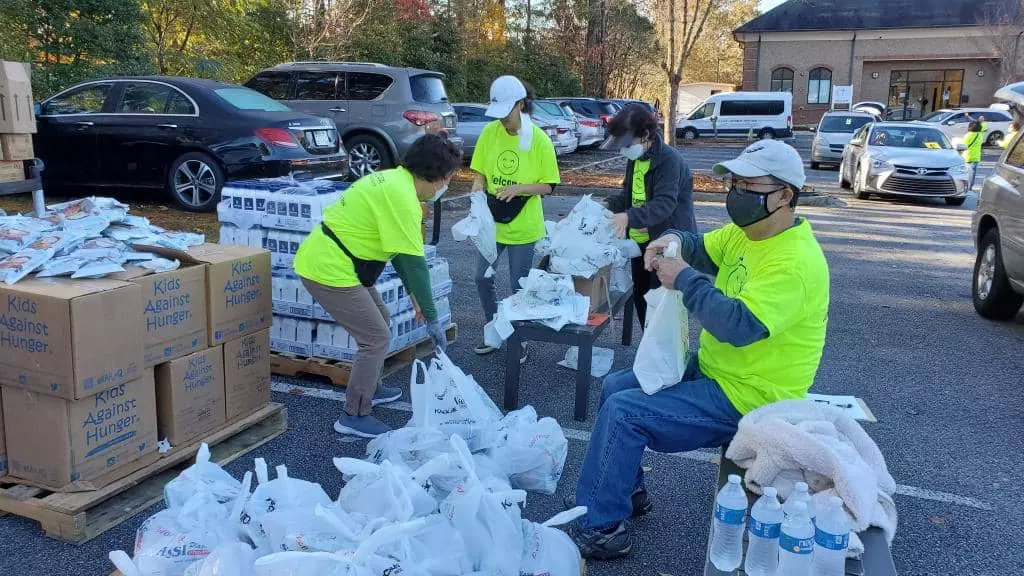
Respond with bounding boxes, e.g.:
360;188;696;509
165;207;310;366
294;134;462;438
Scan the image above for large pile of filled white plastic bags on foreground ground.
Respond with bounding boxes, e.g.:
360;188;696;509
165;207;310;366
110;354;586;576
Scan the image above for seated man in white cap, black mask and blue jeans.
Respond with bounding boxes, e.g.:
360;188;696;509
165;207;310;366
569;140;828;560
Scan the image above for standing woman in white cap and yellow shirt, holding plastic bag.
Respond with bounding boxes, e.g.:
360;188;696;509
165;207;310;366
470;76;560;360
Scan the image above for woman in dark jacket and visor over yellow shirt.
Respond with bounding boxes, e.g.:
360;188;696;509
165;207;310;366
601;105;697;326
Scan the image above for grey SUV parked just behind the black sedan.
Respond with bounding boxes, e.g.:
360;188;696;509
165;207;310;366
246;63;463;177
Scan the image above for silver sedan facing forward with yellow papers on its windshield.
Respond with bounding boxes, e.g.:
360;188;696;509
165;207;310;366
839;122;969;206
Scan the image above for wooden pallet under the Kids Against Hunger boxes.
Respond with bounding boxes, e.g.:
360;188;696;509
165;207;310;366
0;404;288;544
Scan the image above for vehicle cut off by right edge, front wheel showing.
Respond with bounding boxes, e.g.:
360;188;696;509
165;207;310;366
971;82;1024;320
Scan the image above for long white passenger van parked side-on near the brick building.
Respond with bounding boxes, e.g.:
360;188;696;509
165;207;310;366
676;92;793;140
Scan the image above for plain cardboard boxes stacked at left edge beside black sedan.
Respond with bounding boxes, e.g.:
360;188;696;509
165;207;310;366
0;60;36;183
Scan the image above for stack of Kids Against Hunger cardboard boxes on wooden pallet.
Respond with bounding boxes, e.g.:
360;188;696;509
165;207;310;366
0;244;271;490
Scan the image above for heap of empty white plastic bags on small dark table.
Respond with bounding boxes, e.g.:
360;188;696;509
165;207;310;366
483;269;590;347
